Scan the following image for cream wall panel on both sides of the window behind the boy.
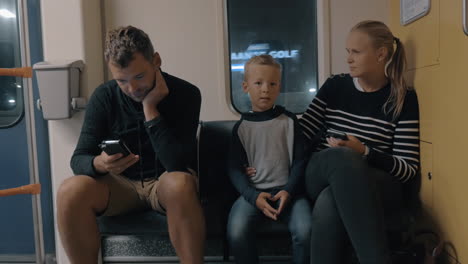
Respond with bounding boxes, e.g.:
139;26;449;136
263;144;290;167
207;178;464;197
104;0;388;120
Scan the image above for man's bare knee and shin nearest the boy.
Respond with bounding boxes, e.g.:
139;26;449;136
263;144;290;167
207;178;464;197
156;172;205;264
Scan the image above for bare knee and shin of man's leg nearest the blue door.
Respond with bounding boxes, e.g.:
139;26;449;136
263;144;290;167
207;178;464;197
57;176;109;264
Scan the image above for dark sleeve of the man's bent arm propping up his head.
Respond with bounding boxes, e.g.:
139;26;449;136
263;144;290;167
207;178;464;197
145;83;201;172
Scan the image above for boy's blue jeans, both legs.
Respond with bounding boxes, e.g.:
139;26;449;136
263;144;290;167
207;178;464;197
227;193;312;264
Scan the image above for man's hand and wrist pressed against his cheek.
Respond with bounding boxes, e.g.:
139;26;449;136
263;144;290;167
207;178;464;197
142;68;169;121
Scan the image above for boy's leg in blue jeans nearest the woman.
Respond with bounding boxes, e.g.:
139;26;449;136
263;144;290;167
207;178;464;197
281;197;312;264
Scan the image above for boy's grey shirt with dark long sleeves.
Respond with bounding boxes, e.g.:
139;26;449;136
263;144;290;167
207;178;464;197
229;106;308;206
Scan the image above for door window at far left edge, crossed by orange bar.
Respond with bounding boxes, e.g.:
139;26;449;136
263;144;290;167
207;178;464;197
0;0;24;127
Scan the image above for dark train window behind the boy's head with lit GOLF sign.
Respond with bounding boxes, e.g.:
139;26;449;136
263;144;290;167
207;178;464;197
226;0;318;114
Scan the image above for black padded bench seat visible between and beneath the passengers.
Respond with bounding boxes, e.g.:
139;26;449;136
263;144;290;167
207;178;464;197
98;121;420;259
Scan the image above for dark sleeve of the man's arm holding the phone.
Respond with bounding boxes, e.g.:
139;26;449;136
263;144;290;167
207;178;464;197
70;87;111;177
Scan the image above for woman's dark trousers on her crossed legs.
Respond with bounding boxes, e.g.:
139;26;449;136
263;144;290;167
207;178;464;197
306;147;402;264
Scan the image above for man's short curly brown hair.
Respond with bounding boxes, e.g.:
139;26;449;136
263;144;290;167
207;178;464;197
104;26;154;68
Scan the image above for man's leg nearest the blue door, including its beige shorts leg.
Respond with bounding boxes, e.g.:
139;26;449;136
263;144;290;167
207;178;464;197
57;174;148;264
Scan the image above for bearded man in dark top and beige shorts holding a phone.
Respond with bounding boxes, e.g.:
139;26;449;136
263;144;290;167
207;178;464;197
57;26;205;263
